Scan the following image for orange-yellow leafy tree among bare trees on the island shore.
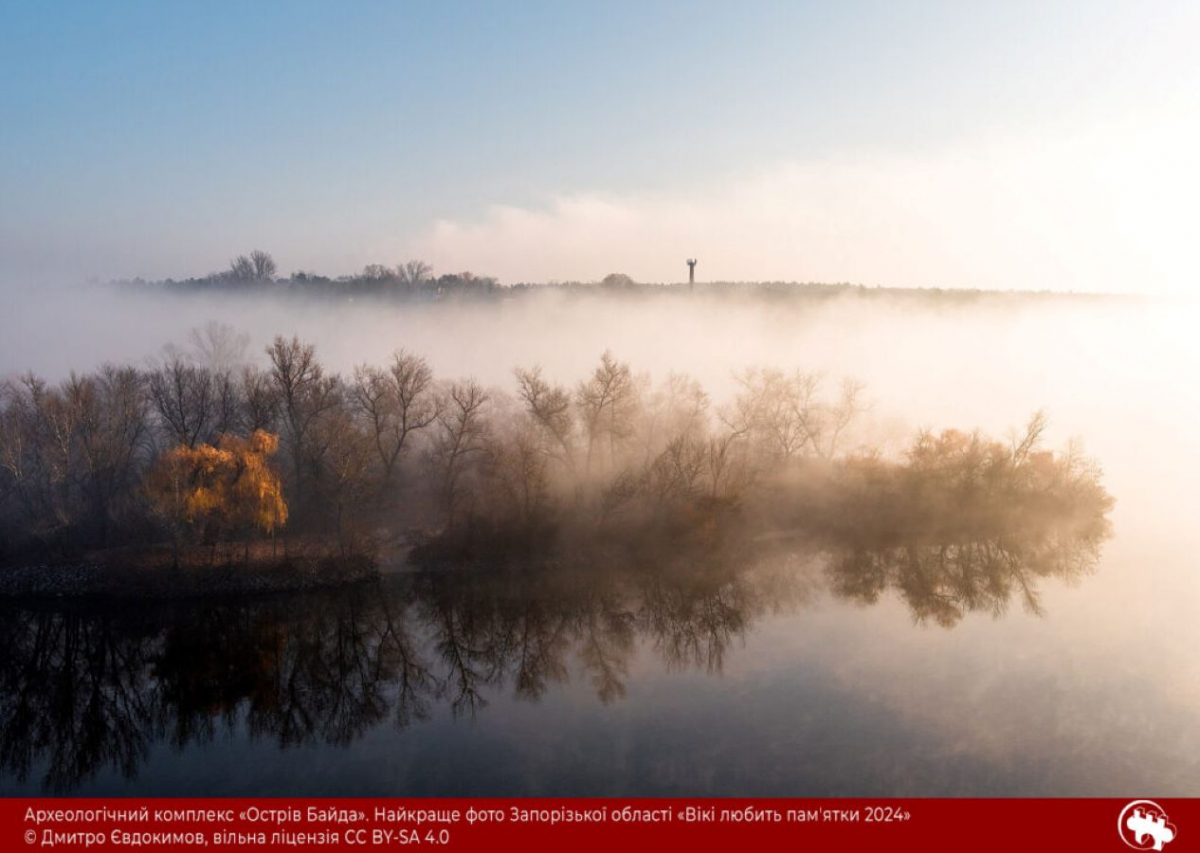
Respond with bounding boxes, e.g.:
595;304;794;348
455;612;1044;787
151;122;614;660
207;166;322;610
146;429;288;565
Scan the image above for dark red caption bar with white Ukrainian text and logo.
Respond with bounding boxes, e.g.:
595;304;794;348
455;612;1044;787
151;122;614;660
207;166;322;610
0;799;1200;853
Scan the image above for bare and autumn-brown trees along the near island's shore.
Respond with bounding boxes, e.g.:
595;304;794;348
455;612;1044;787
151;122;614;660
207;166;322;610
0;324;1111;580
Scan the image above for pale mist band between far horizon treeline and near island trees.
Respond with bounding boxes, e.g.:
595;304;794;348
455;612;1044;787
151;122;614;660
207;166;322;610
0;280;1200;595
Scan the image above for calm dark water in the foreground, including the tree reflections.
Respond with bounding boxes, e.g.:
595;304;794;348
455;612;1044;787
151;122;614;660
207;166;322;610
0;520;1198;795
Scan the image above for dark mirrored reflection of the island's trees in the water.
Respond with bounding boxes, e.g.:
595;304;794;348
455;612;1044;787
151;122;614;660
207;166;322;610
0;501;1105;793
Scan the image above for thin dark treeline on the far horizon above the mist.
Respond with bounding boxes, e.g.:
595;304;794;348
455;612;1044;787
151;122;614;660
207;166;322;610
114;250;1113;304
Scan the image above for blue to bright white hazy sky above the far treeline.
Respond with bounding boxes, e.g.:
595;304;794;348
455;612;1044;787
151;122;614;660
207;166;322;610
0;0;1200;292
